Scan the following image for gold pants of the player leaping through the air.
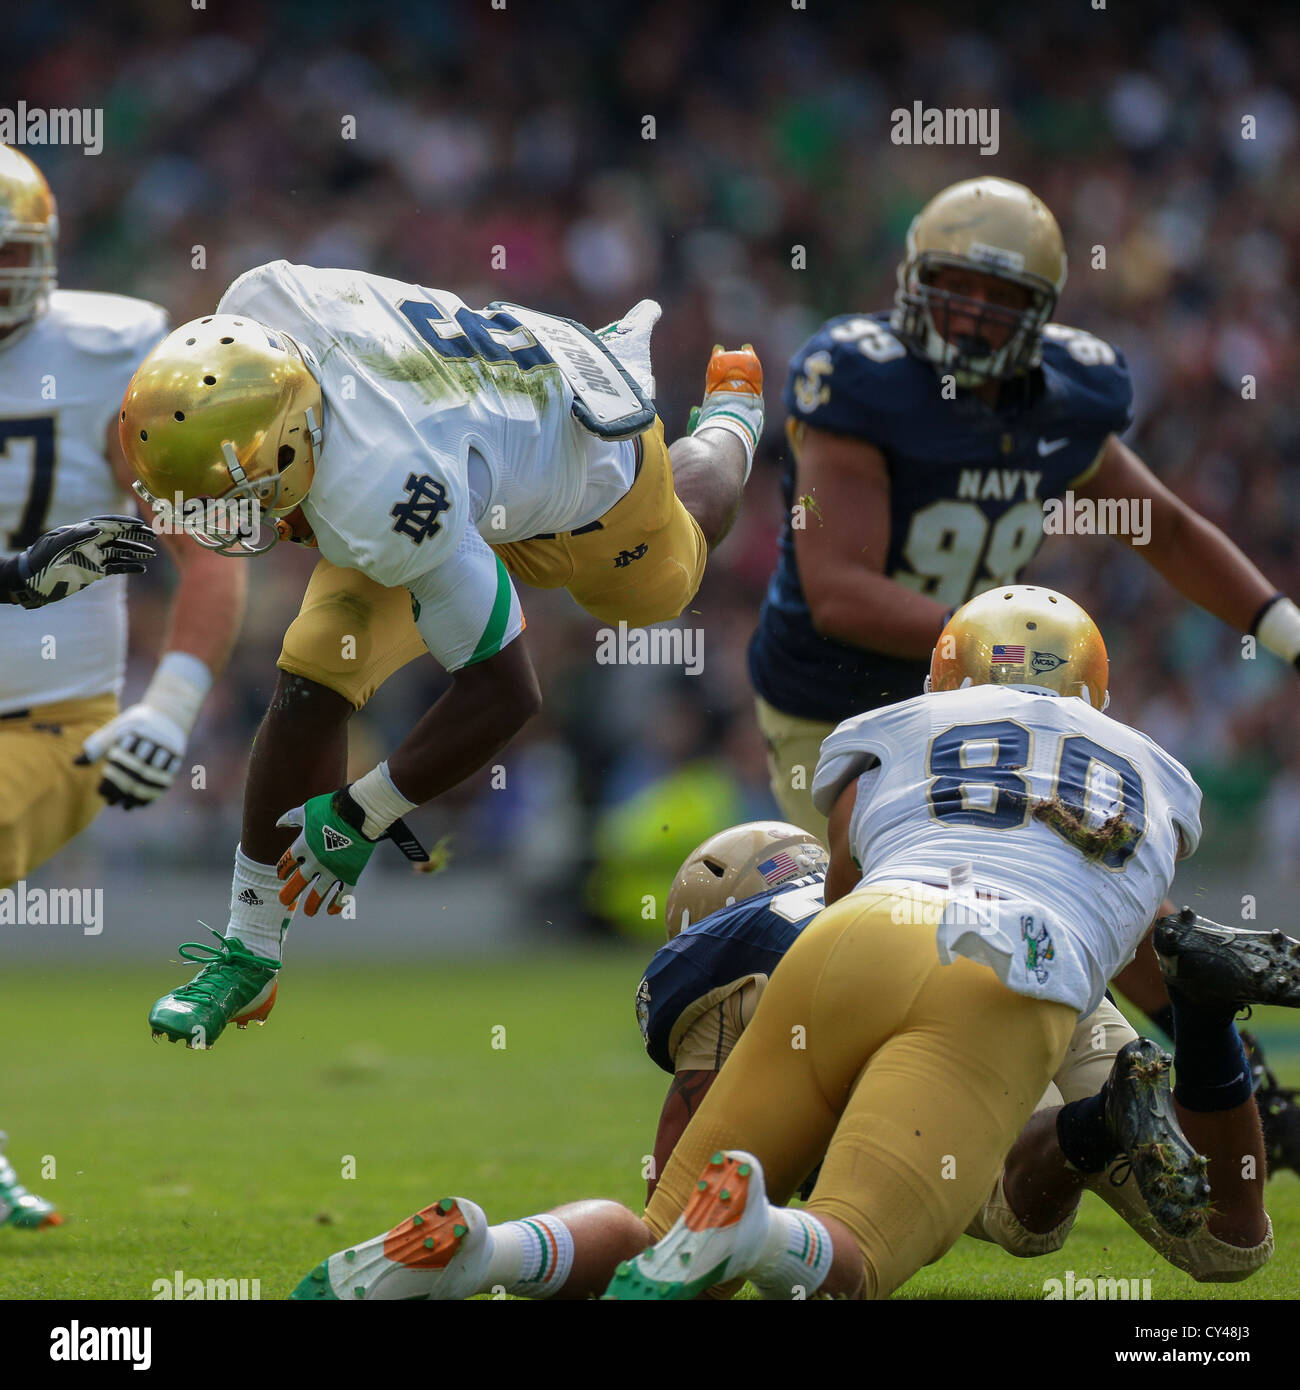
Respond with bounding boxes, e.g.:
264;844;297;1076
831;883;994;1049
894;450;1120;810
278;420;709;709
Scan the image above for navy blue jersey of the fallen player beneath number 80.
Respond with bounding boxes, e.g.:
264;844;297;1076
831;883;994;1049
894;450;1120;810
637;873;826;1072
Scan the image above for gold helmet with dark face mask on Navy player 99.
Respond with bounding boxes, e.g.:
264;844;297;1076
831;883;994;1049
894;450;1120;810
893;178;1065;389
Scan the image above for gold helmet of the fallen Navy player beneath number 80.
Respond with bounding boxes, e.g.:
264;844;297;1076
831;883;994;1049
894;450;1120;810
667;820;830;941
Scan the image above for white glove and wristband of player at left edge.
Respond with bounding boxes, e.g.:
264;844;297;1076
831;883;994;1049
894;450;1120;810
76;652;213;810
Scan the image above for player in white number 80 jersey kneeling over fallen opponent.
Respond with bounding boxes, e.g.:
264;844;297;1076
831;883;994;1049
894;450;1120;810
295;588;1300;1300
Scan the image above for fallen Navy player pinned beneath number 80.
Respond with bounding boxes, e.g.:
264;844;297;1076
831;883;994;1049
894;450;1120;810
637;823;1274;1283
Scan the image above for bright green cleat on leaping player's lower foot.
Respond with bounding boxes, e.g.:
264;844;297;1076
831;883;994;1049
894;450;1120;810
149;929;279;1051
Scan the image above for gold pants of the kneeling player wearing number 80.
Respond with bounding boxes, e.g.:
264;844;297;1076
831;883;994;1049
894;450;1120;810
645;885;1078;1298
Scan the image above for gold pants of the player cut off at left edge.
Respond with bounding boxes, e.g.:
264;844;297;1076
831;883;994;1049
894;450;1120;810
0;695;117;888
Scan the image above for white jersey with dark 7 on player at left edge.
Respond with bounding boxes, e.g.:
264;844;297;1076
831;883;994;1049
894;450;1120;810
0;289;167;713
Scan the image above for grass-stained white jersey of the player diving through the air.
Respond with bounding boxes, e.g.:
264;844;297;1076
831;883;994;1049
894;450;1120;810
217;261;635;670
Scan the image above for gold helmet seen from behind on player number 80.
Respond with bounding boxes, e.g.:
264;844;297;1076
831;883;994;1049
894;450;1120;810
926;584;1111;709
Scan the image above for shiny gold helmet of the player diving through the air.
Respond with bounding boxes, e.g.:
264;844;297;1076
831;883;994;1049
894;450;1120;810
118;314;323;556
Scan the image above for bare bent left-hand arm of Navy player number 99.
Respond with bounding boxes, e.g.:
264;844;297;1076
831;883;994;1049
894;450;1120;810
794;425;947;660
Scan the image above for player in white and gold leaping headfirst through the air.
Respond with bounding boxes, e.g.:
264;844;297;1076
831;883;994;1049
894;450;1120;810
121;261;763;1047
